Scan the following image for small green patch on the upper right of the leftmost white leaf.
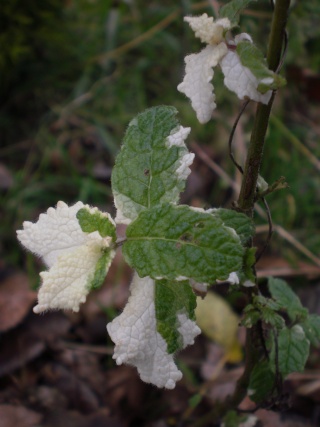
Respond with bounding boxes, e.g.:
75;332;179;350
77;208;116;242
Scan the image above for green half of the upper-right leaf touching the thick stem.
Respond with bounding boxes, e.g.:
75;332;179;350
236;41;286;93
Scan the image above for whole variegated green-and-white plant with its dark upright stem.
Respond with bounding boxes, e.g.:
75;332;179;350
18;0;320;425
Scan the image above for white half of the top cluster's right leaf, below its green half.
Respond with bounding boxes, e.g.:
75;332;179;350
220;50;272;104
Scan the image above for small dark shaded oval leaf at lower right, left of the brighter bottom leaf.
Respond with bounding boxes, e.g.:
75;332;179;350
248;360;275;403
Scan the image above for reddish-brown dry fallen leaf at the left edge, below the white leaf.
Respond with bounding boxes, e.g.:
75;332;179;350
0;273;37;332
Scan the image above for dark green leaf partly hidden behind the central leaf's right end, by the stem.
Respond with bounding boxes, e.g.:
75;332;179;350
208;208;255;245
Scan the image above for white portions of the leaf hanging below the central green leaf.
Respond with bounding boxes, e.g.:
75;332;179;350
107;273;200;389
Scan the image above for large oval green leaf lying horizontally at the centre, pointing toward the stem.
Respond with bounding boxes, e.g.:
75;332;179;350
122;204;243;283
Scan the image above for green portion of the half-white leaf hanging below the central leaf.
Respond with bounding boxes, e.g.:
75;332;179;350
155;279;197;353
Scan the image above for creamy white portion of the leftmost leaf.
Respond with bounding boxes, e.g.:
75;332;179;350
17;202;114;313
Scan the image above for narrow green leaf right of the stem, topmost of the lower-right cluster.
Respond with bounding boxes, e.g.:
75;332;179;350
268;277;308;321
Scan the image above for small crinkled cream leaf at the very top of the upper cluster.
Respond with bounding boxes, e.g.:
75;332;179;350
184;13;231;45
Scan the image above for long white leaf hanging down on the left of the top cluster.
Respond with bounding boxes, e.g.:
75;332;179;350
178;43;228;123
